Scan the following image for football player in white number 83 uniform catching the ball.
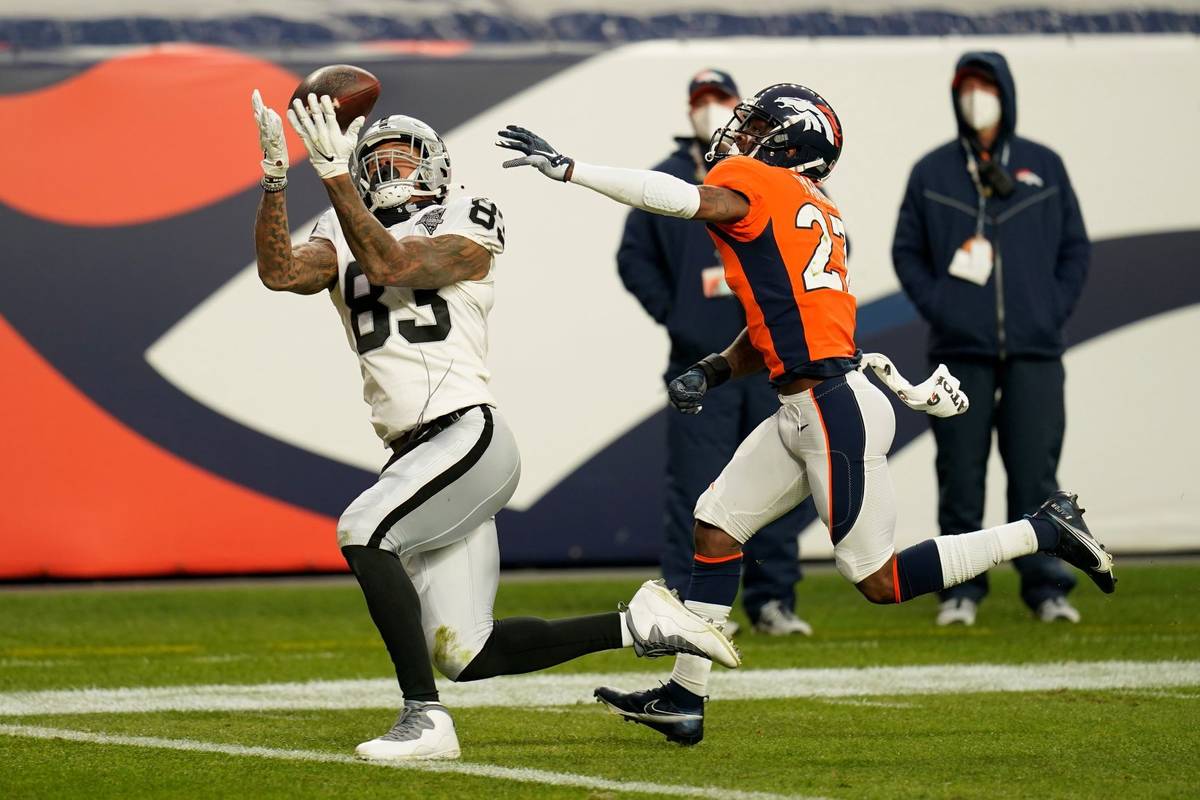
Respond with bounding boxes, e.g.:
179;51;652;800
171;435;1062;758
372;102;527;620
253;91;738;759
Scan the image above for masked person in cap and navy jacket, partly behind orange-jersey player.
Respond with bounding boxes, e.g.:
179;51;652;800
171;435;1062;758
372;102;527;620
617;70;816;636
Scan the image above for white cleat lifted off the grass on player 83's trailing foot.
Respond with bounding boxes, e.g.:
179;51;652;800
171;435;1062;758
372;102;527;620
625;581;742;669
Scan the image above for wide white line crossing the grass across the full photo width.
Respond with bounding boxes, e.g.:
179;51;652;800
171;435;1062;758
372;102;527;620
0;661;1200;717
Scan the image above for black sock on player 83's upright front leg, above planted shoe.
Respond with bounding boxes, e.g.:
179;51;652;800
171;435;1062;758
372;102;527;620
342;545;438;700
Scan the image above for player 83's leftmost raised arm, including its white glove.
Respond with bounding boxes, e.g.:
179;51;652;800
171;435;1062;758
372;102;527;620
250;89;337;294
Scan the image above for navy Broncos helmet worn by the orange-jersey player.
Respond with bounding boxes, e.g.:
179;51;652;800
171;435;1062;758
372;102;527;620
706;83;842;181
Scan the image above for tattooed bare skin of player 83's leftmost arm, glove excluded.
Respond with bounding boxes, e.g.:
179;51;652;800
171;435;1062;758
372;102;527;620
254;192;337;294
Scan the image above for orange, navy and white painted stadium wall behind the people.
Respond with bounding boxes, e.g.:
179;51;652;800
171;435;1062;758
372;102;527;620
0;35;1200;578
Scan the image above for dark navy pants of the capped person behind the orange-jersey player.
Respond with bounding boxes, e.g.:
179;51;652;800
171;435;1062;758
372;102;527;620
662;365;816;620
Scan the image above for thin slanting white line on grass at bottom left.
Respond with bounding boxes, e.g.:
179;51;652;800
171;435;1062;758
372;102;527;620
0;724;822;800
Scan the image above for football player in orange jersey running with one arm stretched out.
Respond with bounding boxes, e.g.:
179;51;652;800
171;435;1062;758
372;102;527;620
497;84;1115;744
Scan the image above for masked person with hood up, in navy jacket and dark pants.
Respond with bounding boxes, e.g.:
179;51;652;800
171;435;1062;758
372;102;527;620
892;53;1091;625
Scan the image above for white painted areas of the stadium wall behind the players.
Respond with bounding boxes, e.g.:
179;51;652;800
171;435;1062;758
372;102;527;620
148;36;1200;554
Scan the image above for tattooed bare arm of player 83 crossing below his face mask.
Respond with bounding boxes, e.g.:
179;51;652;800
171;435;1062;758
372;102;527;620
325;175;492;289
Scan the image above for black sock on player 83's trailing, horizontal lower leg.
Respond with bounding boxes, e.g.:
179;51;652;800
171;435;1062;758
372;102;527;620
455;612;622;680
